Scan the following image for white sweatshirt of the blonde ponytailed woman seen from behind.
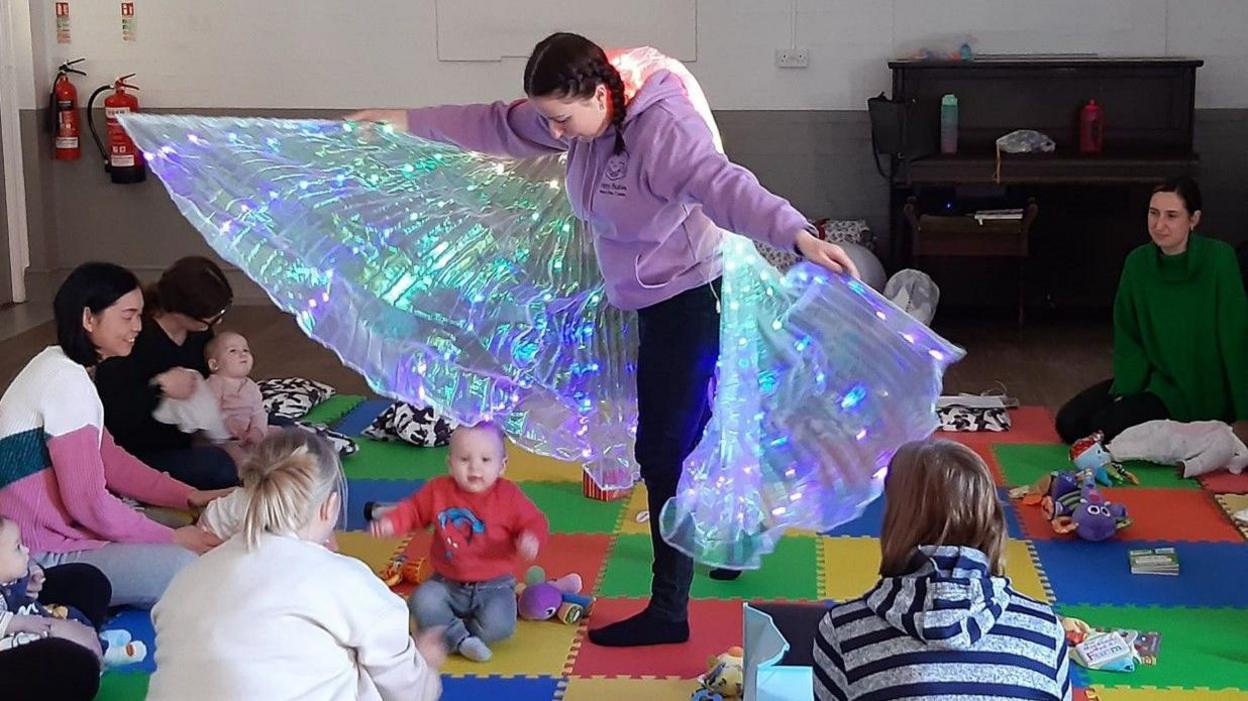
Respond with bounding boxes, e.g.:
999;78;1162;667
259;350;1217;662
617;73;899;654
147;535;442;701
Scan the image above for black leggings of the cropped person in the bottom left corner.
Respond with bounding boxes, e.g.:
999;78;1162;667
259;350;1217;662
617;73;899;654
0;563;112;701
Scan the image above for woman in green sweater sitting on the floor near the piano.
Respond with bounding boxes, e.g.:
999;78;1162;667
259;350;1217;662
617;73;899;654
1057;177;1248;443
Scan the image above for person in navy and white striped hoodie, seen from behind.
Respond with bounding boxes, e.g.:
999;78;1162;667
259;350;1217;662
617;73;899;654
814;440;1071;701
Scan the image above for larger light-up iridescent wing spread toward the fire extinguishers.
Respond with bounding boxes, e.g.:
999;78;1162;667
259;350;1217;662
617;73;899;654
124;115;636;486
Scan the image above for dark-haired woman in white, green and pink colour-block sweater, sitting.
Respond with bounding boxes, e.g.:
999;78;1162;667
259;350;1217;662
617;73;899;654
0;263;227;606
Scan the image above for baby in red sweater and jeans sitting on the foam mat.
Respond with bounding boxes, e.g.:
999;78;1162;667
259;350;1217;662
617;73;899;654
369;422;550;662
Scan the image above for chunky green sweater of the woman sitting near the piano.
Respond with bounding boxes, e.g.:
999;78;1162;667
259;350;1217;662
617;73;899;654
1111;234;1248;422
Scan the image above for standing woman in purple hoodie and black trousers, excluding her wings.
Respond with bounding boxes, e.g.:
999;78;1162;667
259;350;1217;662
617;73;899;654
347;32;857;646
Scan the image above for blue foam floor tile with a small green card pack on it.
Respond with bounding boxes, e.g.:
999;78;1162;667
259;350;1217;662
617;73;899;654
1033;540;1248;609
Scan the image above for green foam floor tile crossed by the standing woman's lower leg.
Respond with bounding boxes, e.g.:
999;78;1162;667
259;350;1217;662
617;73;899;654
595;535;819;601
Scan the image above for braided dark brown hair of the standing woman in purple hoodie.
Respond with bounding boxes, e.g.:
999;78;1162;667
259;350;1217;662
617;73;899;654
524;31;625;153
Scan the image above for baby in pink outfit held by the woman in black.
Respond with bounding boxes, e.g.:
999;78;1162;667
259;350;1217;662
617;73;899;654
203;331;268;448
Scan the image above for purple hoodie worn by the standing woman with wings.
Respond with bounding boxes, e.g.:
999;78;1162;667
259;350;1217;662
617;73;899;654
407;71;806;309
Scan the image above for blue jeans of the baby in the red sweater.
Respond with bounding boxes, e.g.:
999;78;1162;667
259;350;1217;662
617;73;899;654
407;574;515;651
